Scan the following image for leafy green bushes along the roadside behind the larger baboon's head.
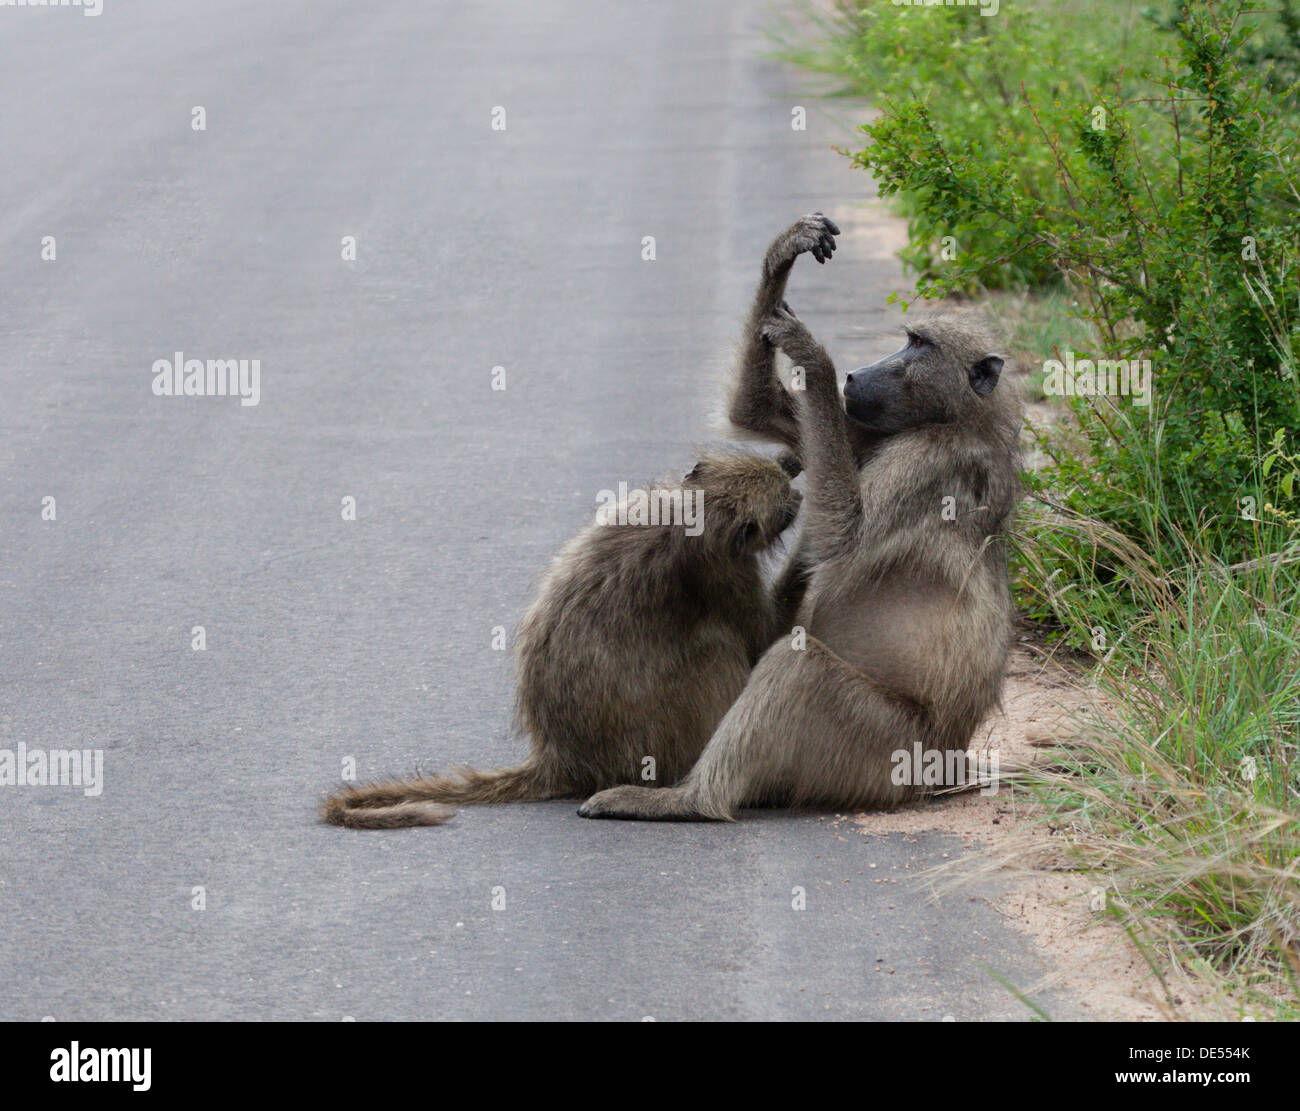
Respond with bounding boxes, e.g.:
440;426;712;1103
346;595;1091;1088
790;0;1300;626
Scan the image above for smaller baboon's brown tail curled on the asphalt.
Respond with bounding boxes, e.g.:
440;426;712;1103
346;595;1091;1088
321;763;556;829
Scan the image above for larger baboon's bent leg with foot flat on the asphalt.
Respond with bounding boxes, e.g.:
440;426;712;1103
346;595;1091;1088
579;637;927;821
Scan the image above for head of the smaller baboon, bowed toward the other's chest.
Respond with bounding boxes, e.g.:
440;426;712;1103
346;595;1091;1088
683;455;803;554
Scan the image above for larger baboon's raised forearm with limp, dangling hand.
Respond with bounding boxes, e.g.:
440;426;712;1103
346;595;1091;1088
729;213;840;451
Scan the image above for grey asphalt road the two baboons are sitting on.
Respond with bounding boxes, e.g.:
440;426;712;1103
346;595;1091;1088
0;0;1066;1020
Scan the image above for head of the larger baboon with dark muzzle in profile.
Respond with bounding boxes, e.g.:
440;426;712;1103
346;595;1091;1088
844;324;1002;437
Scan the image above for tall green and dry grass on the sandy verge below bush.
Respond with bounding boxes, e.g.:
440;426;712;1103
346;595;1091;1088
1019;431;1300;1017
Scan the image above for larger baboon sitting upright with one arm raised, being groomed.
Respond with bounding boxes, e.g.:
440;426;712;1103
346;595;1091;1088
579;218;1019;820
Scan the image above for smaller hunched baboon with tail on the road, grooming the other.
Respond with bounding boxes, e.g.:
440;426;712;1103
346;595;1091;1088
321;455;800;829
